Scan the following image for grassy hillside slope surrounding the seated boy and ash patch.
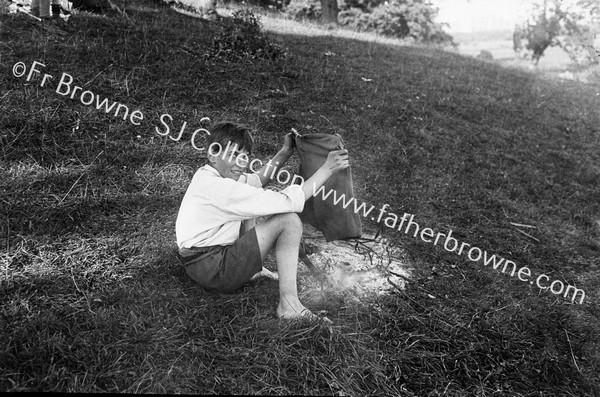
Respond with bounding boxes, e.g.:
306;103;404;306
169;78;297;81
0;5;600;395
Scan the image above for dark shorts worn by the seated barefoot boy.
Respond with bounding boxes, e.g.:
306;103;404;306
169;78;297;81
179;229;262;292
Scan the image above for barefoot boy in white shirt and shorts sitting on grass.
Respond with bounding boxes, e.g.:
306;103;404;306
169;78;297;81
176;122;349;319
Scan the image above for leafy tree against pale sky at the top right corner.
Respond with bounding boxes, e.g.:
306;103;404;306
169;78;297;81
513;0;600;65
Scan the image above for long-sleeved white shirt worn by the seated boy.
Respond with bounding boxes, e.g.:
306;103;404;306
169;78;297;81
175;164;304;248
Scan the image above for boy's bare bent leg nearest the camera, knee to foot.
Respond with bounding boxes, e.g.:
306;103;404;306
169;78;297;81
256;213;316;319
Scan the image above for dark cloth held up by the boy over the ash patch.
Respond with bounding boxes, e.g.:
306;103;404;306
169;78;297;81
295;134;362;241
